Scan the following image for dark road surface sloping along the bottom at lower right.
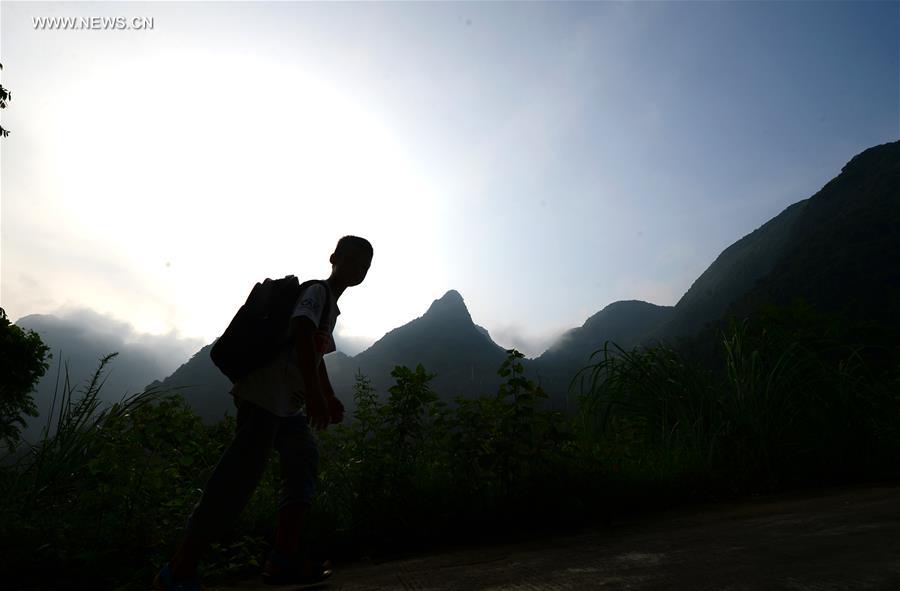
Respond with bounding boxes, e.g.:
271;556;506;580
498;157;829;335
216;487;900;591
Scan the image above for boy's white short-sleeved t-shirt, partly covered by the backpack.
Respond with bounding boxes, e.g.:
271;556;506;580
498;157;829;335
231;283;341;417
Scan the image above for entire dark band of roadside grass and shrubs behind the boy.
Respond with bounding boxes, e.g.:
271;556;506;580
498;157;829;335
0;308;900;589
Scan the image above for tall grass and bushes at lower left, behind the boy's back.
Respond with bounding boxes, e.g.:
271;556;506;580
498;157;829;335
0;353;243;586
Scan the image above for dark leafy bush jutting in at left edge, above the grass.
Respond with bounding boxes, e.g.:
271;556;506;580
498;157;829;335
0;308;52;453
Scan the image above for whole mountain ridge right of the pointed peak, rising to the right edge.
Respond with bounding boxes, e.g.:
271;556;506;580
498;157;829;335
533;142;900;392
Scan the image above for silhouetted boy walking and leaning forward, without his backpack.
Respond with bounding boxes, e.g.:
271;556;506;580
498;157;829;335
153;236;373;591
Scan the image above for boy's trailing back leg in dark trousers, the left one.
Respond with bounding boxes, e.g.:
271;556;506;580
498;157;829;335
170;401;279;579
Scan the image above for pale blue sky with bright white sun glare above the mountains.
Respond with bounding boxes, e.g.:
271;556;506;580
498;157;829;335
0;0;900;369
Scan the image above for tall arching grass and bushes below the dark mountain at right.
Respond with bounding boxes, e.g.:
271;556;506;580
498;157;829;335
580;304;900;491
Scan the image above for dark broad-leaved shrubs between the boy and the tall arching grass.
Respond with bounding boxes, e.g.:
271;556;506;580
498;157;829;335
316;350;567;545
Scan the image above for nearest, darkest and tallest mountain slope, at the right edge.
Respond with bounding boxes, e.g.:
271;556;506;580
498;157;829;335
704;141;900;366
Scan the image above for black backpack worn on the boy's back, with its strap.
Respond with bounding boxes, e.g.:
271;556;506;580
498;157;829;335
209;275;331;383
